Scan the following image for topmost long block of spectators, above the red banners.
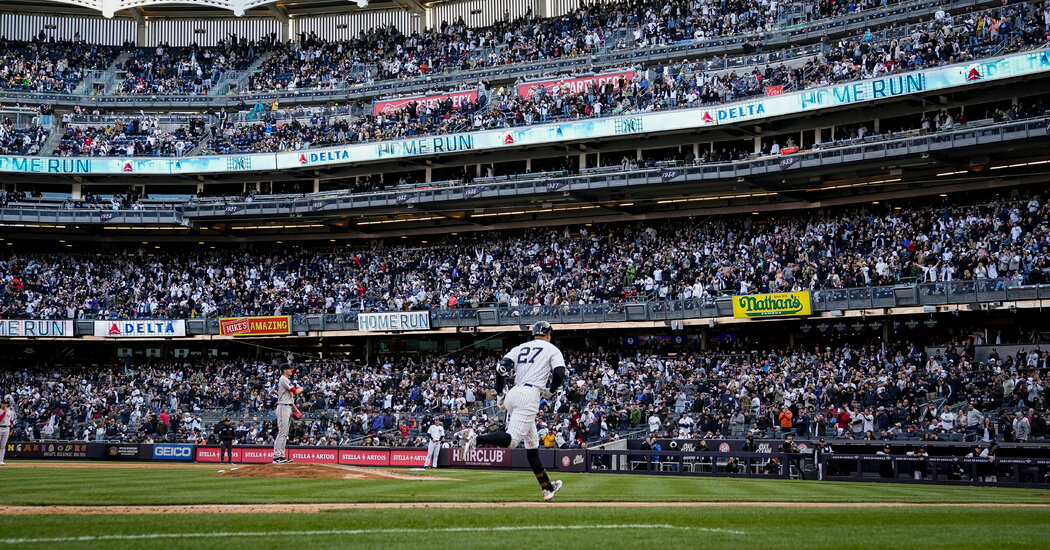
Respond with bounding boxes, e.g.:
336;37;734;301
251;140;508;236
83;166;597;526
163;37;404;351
245;0;797;90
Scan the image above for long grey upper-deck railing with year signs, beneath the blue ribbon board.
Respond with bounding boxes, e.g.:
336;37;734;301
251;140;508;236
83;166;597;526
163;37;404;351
0;112;1050;225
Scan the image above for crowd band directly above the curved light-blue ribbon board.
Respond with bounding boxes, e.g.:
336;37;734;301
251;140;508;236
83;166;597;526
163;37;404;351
81;3;1050;158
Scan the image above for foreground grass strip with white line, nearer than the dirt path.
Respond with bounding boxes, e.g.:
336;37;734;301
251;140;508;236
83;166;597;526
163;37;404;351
0;507;1050;550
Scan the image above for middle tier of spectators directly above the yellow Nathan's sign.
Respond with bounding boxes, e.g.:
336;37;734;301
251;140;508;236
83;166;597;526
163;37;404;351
0;188;1050;318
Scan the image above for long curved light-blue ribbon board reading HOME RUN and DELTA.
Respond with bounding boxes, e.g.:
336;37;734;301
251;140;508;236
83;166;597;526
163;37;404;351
0;49;1050;175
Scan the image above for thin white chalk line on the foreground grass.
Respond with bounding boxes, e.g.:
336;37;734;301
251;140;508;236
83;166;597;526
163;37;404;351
0;524;747;545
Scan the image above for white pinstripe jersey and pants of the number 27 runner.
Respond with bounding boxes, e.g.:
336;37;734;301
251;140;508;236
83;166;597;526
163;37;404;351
503;339;565;449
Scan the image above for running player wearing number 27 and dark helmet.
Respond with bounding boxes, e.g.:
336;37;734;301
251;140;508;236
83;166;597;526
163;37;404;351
463;321;565;501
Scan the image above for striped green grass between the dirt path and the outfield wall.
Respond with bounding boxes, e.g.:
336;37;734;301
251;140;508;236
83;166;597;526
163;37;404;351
0;464;1050;505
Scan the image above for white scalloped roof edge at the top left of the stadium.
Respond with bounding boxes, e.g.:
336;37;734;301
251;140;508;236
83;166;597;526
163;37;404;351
0;0;417;19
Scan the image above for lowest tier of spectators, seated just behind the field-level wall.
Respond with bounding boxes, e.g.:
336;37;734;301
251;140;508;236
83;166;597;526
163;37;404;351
0;339;1050;448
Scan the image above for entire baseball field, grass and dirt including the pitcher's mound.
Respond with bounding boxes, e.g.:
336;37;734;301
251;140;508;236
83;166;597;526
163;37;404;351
0;462;1050;550
